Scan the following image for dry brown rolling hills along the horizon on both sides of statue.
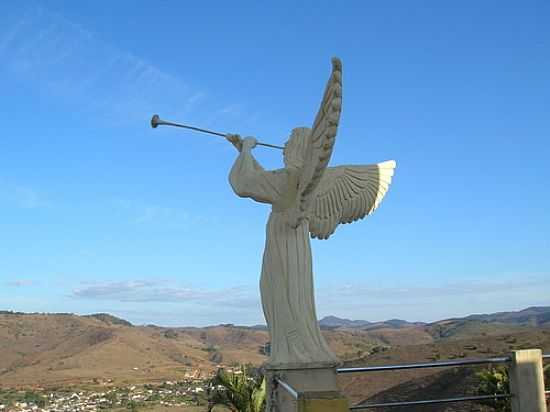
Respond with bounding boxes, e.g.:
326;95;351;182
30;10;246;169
0;308;550;403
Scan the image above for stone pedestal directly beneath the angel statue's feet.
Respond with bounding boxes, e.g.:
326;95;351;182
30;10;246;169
265;363;349;412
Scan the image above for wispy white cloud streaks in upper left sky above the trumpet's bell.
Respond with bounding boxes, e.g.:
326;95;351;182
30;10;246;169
0;5;206;123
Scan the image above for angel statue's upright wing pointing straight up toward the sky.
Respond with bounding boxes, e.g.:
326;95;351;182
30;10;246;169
298;57;342;222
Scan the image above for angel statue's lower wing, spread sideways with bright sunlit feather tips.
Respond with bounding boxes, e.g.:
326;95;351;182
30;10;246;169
308;160;396;239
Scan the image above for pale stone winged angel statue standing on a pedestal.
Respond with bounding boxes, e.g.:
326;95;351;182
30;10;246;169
227;58;396;368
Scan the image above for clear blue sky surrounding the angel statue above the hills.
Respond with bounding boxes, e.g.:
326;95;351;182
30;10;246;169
0;0;550;325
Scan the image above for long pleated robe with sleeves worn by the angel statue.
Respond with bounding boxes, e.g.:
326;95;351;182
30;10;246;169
229;149;337;367
